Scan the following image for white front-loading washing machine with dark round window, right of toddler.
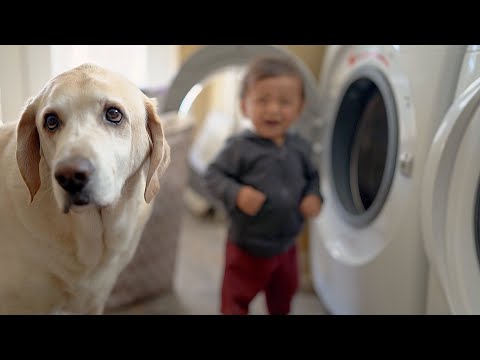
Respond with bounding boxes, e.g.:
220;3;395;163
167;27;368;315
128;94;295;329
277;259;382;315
309;45;465;314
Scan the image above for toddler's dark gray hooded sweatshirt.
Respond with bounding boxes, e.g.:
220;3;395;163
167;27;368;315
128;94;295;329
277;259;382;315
205;130;323;257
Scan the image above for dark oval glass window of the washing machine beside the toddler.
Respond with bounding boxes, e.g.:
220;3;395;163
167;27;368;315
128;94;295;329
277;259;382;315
331;74;398;225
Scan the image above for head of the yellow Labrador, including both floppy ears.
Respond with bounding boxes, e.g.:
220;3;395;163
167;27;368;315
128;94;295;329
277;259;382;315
17;64;170;212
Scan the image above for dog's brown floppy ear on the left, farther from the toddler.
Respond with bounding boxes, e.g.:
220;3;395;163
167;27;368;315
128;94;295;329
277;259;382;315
16;98;40;202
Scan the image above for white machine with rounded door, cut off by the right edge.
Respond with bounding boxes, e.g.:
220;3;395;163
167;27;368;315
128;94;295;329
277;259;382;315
422;45;480;315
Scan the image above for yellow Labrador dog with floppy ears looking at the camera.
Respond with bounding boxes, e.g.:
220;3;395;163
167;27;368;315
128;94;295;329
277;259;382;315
0;64;170;314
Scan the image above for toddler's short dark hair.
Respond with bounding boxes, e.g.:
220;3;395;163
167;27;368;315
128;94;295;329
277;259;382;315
240;56;305;99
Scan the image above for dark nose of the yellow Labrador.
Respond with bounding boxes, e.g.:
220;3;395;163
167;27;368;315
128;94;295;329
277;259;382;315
55;157;95;195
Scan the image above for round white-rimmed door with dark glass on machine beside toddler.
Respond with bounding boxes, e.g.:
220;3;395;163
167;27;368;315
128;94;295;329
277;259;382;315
319;52;415;265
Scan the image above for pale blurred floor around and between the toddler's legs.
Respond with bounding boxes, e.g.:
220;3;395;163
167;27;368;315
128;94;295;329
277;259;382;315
108;208;326;315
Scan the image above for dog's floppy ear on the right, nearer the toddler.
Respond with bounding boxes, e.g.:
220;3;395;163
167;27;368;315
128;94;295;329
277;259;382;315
145;98;170;203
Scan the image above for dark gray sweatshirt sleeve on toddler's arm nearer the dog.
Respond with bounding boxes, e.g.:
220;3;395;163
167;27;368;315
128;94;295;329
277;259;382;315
204;138;242;210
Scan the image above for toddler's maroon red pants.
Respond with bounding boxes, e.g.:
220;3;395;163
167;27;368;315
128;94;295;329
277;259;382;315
221;241;298;315
